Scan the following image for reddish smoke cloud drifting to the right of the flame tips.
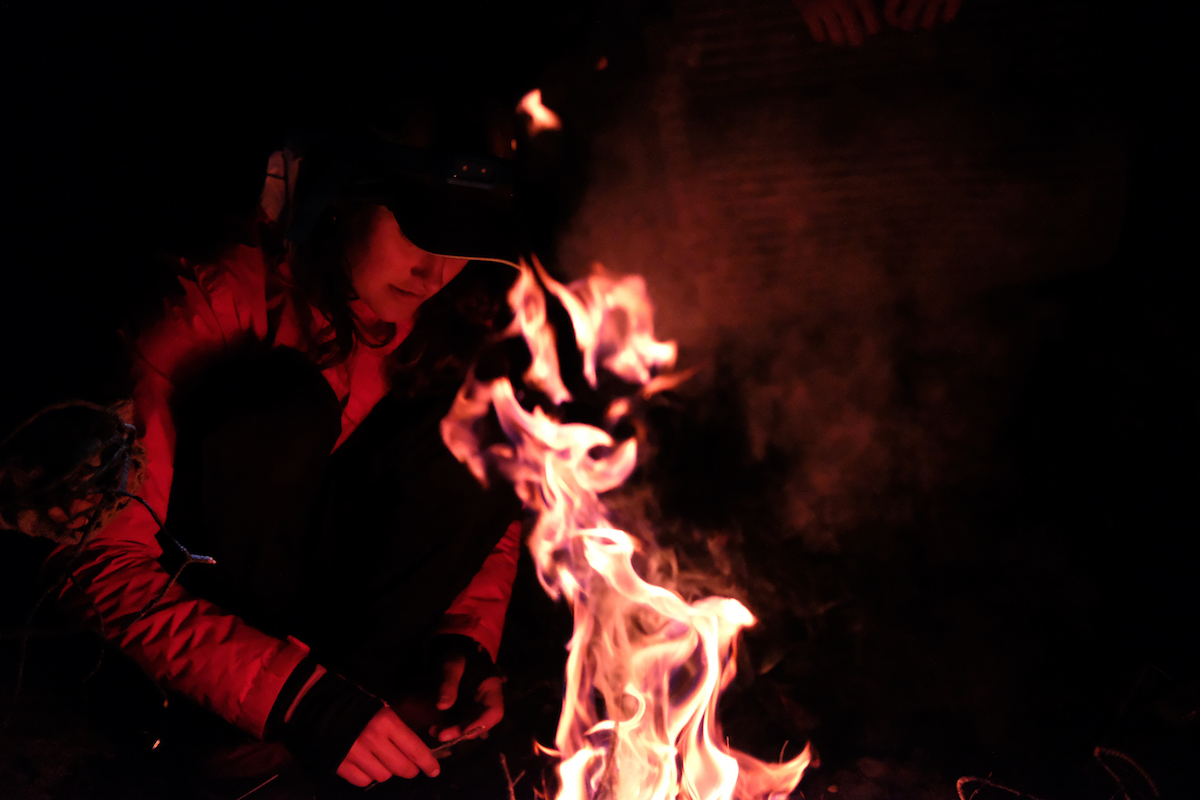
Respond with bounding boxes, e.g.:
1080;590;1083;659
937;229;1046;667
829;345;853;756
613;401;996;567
559;28;1121;563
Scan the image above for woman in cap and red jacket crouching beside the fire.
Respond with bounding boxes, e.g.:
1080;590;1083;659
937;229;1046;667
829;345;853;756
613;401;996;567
30;136;521;787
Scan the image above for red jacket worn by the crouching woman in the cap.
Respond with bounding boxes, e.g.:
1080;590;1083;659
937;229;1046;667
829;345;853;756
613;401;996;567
50;247;521;736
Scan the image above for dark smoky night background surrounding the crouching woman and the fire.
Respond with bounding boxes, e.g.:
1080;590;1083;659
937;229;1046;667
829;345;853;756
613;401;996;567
0;0;1200;800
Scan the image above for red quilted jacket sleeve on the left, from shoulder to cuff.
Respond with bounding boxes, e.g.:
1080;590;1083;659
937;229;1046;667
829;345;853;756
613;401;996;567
50;247;308;735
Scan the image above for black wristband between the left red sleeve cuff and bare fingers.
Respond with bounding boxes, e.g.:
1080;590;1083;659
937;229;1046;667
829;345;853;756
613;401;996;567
281;672;384;775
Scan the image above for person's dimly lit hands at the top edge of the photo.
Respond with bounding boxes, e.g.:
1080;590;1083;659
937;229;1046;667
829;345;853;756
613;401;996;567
792;0;962;47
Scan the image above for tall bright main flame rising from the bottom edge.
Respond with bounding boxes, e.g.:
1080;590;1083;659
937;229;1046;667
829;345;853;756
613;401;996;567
442;260;810;800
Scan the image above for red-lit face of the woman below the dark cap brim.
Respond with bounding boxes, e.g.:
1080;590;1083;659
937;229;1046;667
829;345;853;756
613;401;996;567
349;205;467;325
